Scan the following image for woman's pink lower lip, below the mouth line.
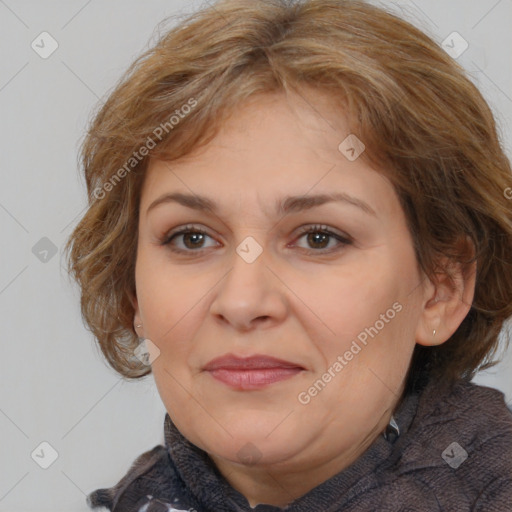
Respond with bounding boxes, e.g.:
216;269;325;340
208;368;302;390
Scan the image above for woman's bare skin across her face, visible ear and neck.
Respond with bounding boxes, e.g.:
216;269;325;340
133;91;474;506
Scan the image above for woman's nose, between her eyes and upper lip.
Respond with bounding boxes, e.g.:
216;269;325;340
210;240;288;332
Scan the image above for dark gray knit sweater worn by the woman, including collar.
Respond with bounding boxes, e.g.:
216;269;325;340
87;380;512;512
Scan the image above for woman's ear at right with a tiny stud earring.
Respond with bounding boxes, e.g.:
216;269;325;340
416;238;477;346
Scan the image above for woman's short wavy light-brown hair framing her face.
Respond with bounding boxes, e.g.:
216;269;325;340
66;0;512;390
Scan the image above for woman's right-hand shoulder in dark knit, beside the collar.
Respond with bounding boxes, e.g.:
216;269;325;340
388;380;512;512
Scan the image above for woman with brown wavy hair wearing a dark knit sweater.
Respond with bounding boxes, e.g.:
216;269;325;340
64;0;512;512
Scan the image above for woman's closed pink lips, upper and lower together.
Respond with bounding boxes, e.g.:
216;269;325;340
203;354;305;390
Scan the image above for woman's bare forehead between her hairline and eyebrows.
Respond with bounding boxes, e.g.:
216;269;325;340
141;93;397;219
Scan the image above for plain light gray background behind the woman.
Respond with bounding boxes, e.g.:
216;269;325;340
0;0;512;512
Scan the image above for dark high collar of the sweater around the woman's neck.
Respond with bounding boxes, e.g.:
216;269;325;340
164;386;418;512
